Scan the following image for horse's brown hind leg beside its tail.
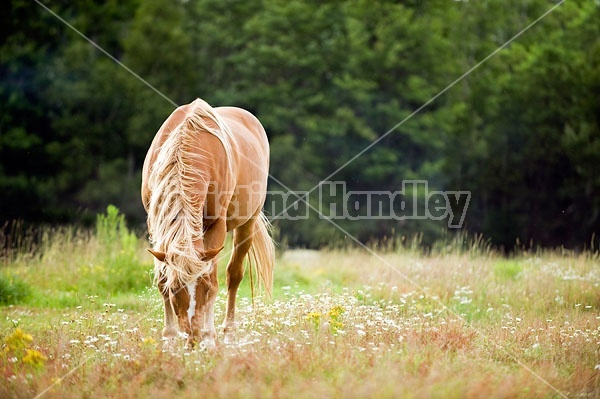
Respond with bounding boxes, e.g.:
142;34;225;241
223;219;255;342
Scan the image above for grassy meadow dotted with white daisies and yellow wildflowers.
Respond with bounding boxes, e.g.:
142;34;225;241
0;208;600;398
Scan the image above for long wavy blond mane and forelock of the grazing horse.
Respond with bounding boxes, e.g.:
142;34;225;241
148;99;233;290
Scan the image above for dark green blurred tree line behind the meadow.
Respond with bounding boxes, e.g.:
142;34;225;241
0;0;600;248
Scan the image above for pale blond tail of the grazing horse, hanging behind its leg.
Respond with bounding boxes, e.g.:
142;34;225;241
249;212;275;296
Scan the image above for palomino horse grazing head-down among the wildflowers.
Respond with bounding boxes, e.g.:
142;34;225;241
142;99;275;347
